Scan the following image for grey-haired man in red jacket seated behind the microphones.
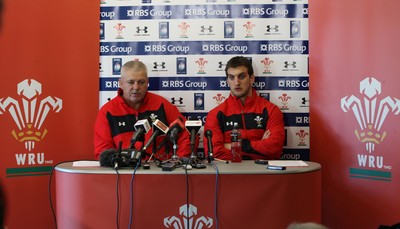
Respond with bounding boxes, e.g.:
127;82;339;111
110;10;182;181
94;61;190;162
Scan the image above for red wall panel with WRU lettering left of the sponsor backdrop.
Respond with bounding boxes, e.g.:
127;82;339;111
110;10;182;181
0;0;99;228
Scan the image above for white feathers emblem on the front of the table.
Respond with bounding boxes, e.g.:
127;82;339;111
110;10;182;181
164;204;213;229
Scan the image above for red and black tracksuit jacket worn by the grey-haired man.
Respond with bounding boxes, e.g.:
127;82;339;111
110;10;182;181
94;89;193;159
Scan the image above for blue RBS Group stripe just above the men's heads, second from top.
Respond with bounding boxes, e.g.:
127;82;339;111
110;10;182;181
100;40;308;56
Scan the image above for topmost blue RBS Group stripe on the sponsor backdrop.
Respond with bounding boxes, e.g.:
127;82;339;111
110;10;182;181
100;4;308;21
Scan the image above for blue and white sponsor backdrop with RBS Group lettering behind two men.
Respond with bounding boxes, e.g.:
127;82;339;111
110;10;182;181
99;0;310;160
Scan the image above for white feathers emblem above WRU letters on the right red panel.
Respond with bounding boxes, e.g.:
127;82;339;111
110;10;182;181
341;77;400;153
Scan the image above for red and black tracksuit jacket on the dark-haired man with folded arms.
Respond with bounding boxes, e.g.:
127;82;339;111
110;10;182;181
203;89;285;160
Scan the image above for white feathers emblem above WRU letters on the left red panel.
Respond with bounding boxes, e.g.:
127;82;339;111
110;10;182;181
0;79;62;151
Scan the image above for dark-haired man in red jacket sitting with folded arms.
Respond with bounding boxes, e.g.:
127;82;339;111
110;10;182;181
203;56;285;160
